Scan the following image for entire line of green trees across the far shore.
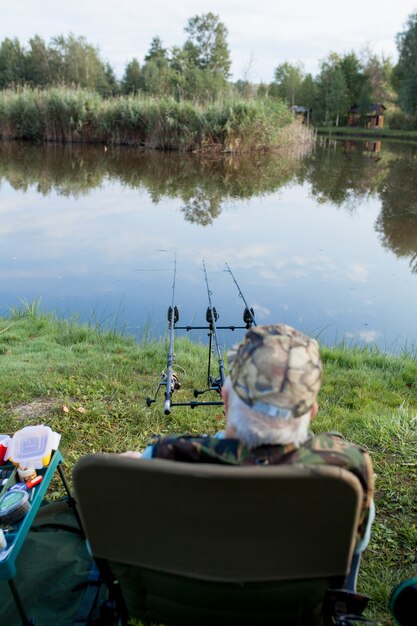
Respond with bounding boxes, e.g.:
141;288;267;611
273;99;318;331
0;11;417;128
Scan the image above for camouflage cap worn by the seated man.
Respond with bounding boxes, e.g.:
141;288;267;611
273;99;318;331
228;324;323;419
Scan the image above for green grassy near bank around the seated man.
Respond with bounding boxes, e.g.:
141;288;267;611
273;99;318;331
0;305;417;625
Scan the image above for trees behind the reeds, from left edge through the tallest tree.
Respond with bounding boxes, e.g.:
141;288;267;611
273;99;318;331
0;13;231;100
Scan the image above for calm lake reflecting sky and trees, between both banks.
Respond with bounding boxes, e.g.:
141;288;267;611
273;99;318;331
0;139;417;353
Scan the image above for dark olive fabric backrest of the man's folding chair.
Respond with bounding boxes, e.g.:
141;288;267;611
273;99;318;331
74;454;362;623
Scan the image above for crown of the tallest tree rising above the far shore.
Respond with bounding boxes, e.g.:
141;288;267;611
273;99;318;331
184;13;231;80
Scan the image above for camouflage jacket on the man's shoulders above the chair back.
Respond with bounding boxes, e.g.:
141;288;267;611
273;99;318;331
152;433;374;543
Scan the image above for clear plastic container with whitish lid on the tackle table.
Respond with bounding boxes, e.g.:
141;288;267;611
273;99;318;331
5;425;61;469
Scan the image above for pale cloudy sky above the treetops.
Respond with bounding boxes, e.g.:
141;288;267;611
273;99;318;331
0;0;417;83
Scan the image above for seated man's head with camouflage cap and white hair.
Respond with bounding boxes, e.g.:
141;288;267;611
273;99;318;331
224;324;323;447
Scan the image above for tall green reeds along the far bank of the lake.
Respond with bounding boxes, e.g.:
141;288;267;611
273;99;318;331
0;87;313;153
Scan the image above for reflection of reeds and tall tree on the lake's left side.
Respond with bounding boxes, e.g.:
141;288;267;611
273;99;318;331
0;142;307;226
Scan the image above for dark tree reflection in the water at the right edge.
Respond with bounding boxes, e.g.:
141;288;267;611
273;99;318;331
298;141;417;272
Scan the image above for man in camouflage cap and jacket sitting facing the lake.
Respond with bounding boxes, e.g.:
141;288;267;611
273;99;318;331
127;324;374;590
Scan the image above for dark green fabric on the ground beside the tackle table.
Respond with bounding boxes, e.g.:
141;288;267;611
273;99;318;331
0;499;100;626
